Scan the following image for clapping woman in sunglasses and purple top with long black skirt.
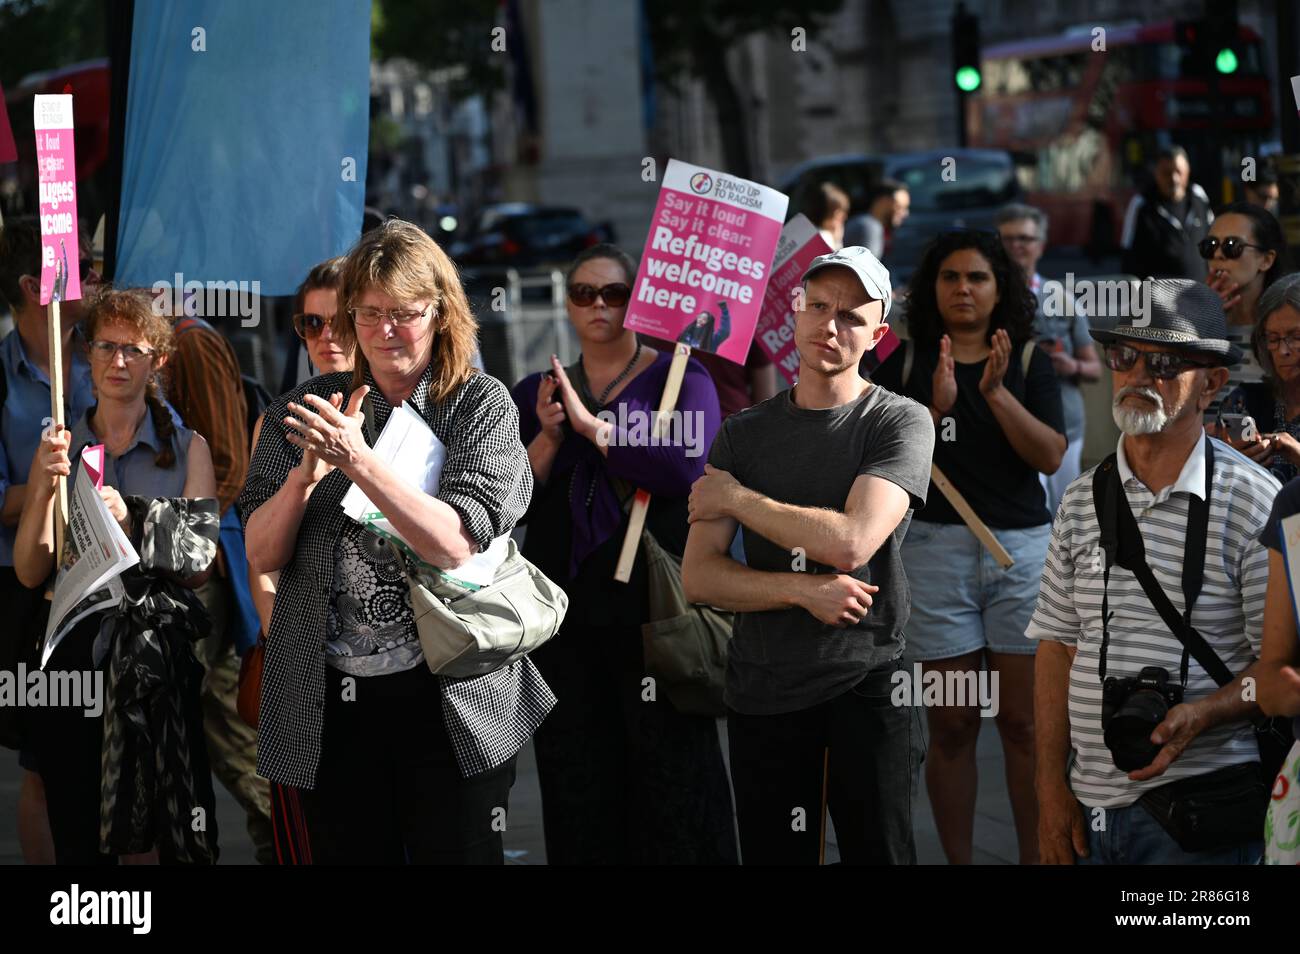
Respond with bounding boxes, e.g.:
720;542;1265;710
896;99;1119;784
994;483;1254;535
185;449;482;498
514;244;737;864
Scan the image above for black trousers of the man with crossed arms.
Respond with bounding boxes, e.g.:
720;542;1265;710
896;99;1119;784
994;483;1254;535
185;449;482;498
727;662;924;864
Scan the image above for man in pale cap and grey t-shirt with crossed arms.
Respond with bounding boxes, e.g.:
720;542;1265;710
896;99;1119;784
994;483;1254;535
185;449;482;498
683;247;935;864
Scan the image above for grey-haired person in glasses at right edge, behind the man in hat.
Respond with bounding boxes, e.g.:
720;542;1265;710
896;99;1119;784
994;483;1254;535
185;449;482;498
1206;274;1300;483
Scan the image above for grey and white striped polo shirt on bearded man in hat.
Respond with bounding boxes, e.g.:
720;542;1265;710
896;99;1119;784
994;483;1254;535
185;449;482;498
1026;437;1279;808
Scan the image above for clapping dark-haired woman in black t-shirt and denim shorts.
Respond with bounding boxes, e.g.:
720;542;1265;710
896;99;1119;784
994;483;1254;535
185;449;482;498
871;230;1066;864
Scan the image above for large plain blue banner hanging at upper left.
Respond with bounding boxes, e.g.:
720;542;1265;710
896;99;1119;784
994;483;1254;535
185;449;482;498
113;0;371;295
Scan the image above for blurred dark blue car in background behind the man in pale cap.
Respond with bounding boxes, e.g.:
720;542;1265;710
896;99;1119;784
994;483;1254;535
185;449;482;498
779;148;1023;285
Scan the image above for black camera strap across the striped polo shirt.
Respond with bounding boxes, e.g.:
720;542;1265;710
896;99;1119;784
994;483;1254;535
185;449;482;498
1092;437;1234;686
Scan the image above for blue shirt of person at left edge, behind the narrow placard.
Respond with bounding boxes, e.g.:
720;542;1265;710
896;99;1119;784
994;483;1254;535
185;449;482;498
0;329;95;567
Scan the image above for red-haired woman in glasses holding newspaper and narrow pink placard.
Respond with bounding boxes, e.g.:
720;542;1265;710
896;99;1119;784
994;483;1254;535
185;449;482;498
14;290;218;864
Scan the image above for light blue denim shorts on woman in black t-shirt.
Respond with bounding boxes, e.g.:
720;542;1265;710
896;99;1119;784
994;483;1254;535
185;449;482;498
902;520;1052;662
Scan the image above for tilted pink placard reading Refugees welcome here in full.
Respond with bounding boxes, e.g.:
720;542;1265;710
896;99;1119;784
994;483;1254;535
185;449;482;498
624;159;789;364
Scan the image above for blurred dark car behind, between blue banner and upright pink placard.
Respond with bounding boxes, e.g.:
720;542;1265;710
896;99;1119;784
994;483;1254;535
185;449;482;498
447;203;614;269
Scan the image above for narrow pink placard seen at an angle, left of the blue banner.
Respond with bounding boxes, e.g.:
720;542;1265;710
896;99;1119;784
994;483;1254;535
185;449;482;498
34;94;81;304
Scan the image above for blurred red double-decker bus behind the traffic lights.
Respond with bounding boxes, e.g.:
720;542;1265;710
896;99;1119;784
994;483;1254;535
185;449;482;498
966;21;1273;253
